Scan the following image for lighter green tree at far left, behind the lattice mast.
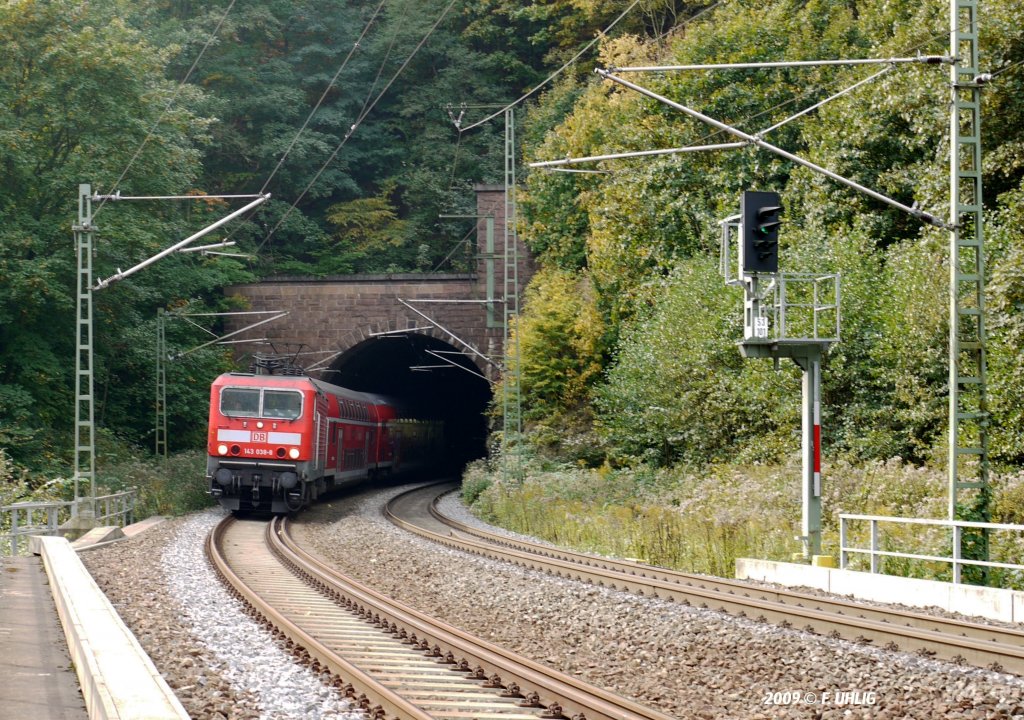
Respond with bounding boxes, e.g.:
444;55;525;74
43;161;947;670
0;0;245;472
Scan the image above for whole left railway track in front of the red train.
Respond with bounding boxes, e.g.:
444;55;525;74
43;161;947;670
207;517;669;720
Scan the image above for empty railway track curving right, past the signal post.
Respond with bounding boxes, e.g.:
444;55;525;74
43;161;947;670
385;484;1024;675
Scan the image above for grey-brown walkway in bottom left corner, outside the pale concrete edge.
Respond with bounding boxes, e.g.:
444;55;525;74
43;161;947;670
0;556;88;720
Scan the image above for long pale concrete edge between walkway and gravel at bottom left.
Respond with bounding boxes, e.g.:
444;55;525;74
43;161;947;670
40;537;188;720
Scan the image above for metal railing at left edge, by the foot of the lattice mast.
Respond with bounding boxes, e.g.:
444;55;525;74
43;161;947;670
0;488;137;555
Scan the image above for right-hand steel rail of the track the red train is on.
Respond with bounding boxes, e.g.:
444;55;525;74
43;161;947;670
274;512;670;720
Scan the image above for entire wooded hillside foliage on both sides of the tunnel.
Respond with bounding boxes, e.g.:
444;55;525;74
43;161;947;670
0;0;1024;524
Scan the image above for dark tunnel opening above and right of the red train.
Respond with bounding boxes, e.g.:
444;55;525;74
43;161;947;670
321;332;492;471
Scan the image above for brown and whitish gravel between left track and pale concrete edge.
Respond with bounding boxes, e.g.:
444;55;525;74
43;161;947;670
82;510;364;720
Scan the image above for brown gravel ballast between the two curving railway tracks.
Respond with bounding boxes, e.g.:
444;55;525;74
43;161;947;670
297;490;1024;718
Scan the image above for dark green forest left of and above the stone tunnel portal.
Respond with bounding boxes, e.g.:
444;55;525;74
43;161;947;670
0;0;626;489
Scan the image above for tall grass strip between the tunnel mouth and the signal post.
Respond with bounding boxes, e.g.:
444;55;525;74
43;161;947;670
467;466;800;576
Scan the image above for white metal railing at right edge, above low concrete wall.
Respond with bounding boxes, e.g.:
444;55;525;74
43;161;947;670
839;514;1024;583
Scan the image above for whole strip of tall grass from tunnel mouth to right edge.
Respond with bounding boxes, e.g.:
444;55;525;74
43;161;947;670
463;459;1024;587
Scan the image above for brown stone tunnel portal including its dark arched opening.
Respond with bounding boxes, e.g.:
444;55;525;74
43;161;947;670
225;185;535;468
